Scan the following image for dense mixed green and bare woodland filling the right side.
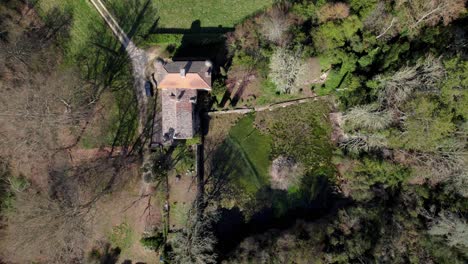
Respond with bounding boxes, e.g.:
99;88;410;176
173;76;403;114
221;0;468;263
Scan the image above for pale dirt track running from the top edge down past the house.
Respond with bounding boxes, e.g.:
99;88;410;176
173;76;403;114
89;0;148;134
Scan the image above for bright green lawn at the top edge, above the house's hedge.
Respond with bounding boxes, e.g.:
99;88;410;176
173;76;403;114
154;0;273;28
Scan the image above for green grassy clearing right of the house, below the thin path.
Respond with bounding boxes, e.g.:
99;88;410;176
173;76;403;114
205;100;333;215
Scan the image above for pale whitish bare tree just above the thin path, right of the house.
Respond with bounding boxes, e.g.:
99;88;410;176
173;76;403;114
269;47;308;93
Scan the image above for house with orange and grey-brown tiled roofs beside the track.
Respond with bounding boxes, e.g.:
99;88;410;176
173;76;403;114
154;60;212;144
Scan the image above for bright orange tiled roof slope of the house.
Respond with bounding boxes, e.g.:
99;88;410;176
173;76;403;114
158;73;211;90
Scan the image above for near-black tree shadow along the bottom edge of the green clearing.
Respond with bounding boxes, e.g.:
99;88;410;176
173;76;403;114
214;176;349;259
